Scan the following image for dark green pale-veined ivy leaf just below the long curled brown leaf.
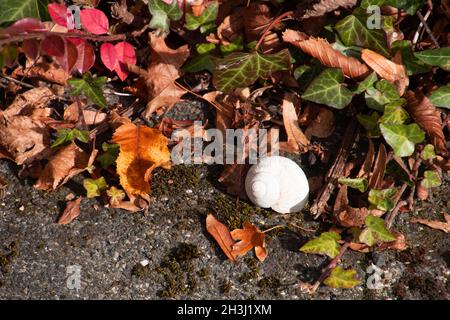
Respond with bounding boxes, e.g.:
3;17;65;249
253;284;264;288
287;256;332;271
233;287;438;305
302;69;353;109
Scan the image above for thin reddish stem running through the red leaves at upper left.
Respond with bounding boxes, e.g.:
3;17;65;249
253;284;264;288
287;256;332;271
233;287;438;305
0;31;126;45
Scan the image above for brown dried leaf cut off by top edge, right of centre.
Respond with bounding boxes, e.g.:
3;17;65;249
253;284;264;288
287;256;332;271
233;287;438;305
296;0;358;19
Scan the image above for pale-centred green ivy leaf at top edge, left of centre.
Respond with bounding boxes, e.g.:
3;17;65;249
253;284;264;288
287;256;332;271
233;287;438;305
148;0;183;32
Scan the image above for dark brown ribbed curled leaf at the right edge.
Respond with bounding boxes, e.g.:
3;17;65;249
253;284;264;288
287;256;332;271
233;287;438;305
406;90;447;154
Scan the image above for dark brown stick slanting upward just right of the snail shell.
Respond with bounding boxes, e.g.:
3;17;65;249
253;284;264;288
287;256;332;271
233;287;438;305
310;121;359;219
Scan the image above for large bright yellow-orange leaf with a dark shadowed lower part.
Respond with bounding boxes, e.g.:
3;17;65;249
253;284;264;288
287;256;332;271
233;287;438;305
113;123;170;201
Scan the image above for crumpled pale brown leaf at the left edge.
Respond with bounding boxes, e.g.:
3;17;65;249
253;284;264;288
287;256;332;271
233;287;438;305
0;114;51;165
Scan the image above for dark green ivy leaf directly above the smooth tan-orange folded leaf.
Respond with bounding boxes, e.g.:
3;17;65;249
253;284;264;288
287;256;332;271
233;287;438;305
335;14;389;56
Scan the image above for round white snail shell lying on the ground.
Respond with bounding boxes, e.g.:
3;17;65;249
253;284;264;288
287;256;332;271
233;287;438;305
245;156;309;213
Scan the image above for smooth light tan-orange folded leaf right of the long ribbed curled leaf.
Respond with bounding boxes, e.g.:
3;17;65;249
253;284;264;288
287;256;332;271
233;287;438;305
361;49;409;96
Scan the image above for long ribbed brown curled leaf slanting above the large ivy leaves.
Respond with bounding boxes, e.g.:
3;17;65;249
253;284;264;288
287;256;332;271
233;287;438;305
283;30;369;79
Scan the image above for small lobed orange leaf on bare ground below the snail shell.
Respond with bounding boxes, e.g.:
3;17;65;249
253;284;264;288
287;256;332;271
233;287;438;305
231;222;267;262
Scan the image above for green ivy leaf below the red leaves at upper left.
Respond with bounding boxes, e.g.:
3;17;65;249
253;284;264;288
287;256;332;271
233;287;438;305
67;72;107;108
